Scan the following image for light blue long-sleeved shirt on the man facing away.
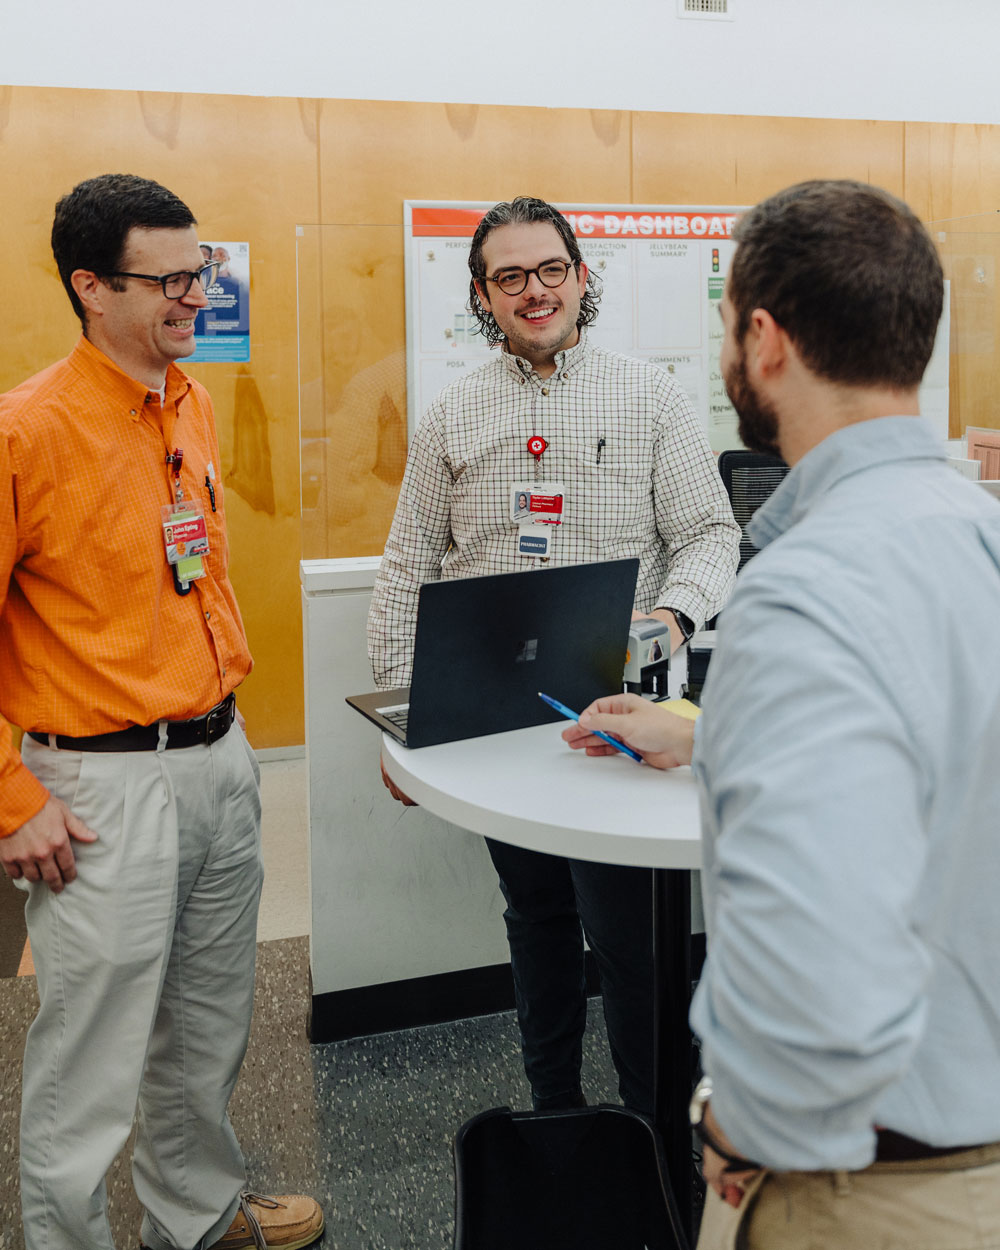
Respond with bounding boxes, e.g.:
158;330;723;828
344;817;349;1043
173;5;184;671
691;416;1000;1169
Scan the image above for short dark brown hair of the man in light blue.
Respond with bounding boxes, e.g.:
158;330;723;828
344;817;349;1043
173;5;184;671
726;180;944;388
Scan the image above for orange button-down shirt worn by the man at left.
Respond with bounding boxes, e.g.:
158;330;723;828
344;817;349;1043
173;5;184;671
0;339;253;836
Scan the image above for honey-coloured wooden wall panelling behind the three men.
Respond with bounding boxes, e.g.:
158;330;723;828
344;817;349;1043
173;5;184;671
0;86;1000;748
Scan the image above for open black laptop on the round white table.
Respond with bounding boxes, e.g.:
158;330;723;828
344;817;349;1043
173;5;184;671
348;559;639;746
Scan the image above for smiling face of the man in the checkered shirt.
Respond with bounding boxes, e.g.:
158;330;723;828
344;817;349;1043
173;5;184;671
476;221;586;378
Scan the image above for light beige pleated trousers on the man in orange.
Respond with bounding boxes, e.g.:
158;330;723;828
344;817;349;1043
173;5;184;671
21;725;263;1250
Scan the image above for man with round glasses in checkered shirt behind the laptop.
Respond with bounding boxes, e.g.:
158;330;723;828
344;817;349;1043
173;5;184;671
369;198;740;1114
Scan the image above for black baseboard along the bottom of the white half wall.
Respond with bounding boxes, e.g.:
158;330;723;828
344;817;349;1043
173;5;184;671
309;951;600;1044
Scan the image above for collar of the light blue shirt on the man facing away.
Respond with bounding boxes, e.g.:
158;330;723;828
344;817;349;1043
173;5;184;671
746;416;945;548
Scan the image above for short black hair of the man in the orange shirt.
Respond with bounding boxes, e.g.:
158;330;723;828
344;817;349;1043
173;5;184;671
51;174;198;325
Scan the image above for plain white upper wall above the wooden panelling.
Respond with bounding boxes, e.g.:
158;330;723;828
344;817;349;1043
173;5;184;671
0;0;1000;123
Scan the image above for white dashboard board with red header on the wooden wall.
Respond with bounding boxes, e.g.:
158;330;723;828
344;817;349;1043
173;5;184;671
404;200;950;453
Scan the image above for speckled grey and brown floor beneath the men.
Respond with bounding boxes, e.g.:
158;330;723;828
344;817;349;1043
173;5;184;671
0;938;616;1250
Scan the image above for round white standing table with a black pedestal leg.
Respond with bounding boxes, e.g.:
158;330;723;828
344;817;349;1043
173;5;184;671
383;721;701;1236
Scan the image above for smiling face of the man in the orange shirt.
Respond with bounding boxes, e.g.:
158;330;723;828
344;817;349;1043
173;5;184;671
78;226;208;390
